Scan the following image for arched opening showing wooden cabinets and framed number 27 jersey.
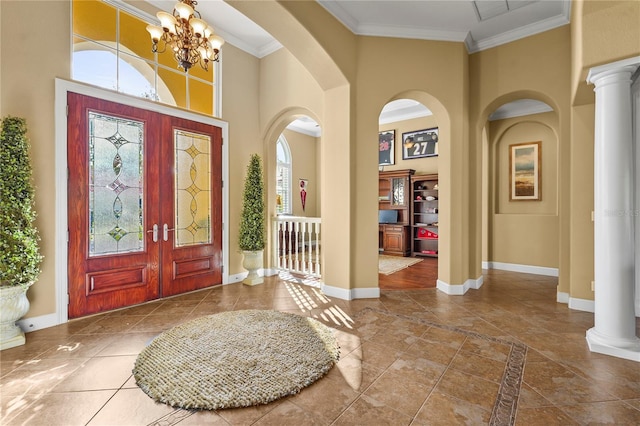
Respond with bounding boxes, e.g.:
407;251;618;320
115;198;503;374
378;98;439;290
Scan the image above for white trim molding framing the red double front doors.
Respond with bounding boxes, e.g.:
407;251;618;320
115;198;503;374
51;78;229;325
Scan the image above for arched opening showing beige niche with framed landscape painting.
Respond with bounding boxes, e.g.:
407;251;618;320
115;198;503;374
481;98;561;277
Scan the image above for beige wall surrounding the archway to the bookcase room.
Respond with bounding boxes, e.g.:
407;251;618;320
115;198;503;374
356;37;470;287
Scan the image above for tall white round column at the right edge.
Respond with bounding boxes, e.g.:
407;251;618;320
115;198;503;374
587;61;640;362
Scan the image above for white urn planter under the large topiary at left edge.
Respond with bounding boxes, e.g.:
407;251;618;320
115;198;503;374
0;285;30;350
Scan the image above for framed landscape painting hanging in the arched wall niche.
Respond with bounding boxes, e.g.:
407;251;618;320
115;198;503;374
509;141;542;201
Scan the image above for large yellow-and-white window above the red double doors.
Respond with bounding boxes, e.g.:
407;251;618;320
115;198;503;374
71;0;222;117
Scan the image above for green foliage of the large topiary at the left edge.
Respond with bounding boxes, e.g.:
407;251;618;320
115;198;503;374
0;116;42;286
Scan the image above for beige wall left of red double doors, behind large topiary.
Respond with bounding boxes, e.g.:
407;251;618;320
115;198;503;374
0;1;71;317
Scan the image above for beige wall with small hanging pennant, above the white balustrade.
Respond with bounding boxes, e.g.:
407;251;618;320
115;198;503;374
283;130;320;217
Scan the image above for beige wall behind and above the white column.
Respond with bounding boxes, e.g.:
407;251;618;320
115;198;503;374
559;0;640;299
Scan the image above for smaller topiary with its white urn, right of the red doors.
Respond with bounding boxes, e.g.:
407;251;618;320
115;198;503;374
239;154;265;285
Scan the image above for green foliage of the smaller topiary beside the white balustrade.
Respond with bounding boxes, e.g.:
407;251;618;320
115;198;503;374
239;154;265;251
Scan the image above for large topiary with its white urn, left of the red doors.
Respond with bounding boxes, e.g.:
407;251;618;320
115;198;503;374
0;117;42;350
